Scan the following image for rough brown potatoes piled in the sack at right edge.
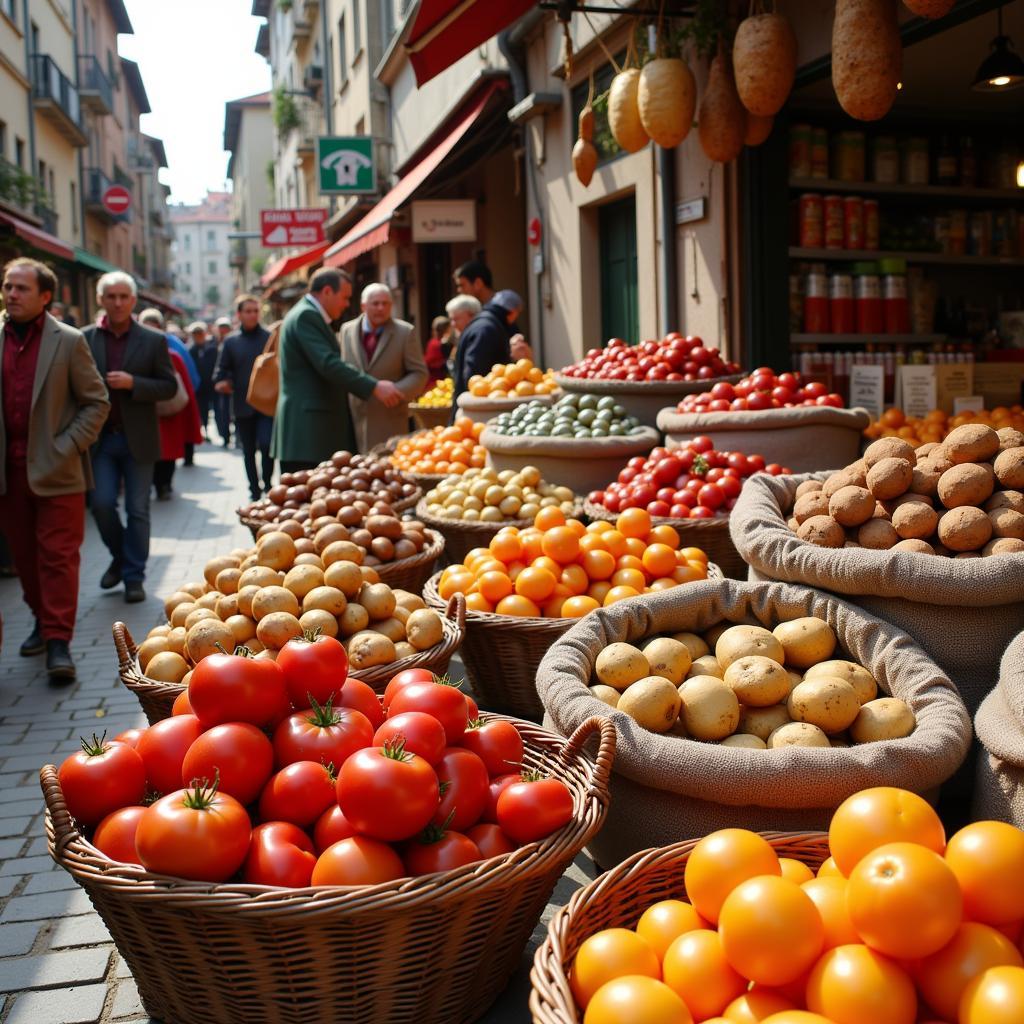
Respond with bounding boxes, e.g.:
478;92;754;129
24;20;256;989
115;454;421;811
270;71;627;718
788;423;1024;558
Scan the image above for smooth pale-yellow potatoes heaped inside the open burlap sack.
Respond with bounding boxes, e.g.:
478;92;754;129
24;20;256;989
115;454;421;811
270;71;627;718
590;616;916;750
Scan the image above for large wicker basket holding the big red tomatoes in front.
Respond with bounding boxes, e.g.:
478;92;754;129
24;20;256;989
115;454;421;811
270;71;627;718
40;719;615;1024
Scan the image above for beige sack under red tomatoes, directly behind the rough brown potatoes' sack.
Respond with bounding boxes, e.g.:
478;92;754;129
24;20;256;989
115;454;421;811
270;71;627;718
657;407;871;473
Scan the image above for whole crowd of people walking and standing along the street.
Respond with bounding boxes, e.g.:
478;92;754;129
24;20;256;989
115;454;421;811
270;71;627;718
0;250;531;682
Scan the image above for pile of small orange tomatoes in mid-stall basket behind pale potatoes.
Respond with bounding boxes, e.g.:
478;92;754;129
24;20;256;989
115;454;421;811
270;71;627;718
437;506;708;618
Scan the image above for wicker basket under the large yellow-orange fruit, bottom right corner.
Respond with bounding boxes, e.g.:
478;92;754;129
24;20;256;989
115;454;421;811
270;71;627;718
529;833;828;1024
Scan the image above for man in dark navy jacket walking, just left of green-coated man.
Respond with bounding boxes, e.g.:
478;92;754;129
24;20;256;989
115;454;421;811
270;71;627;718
213;294;273;502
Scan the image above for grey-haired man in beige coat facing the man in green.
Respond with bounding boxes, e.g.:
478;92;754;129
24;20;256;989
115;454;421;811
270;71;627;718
341;284;427;452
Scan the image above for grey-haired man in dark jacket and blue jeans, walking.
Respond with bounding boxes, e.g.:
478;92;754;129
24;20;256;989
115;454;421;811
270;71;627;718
85;270;177;604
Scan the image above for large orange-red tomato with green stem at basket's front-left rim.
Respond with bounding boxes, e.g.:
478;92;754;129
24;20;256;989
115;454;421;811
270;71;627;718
135;778;252;882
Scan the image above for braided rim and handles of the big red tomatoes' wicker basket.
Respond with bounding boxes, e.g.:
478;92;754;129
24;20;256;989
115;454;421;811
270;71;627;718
40;713;615;924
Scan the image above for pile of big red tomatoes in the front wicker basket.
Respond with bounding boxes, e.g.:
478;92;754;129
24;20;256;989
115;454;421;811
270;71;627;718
59;636;573;888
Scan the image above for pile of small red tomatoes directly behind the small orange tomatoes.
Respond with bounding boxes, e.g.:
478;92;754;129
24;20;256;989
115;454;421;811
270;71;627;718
587;437;790;519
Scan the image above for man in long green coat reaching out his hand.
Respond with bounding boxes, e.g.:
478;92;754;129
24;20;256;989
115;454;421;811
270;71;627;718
270;267;404;473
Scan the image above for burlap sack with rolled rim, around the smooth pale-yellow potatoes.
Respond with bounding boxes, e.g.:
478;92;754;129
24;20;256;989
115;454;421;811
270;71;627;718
537;580;971;867
